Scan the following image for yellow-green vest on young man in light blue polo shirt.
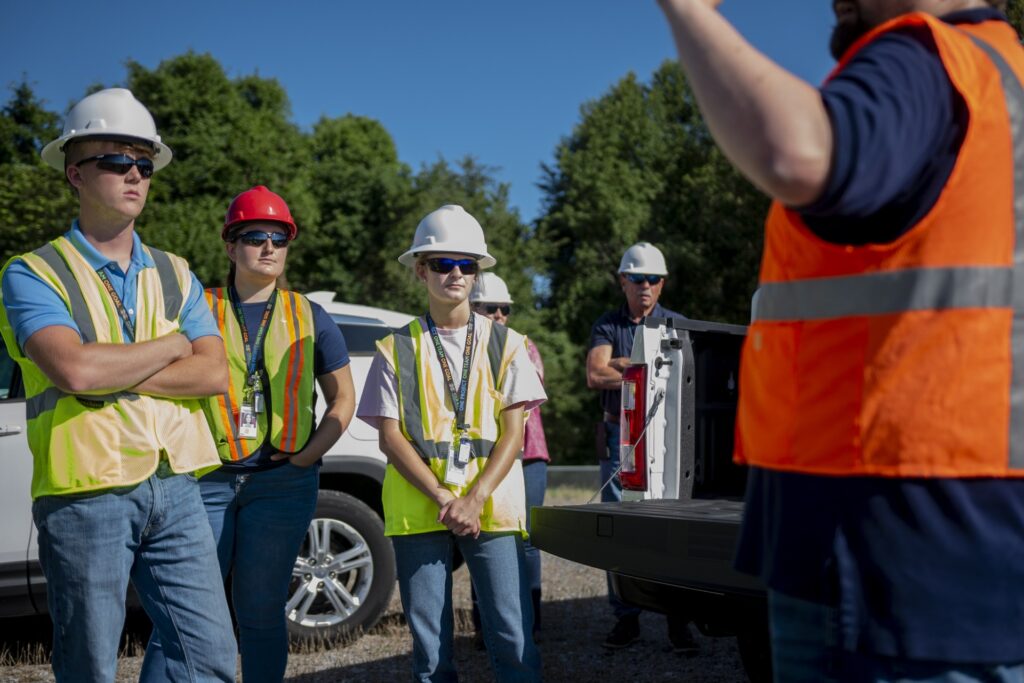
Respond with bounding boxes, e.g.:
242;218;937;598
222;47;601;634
0;237;219;499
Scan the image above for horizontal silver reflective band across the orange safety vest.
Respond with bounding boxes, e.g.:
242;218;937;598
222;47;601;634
754;266;1014;322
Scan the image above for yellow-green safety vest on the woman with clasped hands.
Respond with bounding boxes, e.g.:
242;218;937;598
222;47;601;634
377;313;532;538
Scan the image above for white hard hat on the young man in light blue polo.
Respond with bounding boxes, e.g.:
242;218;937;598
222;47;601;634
42;88;171;171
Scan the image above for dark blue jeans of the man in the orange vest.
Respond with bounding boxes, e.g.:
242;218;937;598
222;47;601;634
768;590;1024;683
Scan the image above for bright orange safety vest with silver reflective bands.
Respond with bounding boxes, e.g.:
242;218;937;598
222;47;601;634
735;13;1024;477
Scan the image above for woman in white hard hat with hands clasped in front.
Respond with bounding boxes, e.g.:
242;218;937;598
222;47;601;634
356;205;546;681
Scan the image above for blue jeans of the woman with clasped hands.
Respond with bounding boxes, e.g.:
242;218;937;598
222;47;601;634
391;531;541;683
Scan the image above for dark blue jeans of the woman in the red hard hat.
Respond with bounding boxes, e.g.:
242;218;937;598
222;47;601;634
151;463;319;683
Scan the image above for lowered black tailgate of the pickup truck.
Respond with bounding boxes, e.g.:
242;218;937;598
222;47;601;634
531;500;764;596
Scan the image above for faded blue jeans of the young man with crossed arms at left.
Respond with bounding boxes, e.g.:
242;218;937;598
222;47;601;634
32;462;236;681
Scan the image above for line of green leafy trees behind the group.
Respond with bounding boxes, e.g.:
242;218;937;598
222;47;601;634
0;52;765;463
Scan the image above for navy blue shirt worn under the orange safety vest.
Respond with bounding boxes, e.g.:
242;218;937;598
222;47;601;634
736;8;1024;663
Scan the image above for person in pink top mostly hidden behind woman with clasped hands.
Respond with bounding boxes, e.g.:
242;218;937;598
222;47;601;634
469;272;551;640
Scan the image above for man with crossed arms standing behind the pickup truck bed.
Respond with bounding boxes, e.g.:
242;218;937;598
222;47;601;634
587;242;697;654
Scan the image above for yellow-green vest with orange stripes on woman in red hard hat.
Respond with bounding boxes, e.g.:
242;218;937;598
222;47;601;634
203;287;316;462
